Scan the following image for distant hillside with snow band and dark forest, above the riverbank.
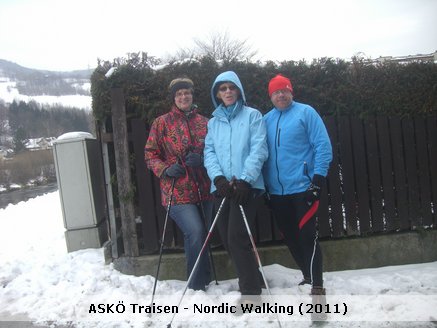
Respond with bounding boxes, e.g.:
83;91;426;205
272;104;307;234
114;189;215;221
0;59;92;150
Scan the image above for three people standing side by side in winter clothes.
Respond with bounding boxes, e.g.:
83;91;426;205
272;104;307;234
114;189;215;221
145;71;332;304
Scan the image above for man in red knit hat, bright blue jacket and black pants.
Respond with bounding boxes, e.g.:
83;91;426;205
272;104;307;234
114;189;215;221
263;75;332;316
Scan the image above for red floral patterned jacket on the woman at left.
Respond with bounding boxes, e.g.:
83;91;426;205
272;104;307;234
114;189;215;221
144;106;212;206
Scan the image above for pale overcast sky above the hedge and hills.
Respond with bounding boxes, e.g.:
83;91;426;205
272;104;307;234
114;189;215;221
0;0;437;70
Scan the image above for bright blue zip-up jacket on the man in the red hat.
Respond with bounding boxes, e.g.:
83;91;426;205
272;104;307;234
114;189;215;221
263;101;332;195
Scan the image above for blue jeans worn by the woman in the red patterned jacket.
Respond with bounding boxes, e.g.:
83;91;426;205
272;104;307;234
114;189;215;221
170;201;213;290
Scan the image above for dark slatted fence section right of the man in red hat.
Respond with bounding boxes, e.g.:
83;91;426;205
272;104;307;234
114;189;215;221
319;116;437;237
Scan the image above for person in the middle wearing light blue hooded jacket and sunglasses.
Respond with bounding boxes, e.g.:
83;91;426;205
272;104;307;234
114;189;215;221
204;71;268;295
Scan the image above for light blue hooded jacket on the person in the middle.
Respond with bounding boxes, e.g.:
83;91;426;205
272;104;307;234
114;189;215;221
204;71;268;192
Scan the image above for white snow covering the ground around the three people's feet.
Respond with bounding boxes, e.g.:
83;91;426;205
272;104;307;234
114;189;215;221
0;191;437;328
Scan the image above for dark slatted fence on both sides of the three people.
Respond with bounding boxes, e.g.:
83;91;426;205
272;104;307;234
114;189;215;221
99;91;437;255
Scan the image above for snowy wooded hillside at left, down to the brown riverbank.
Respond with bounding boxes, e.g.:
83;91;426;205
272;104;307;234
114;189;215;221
0;59;93;192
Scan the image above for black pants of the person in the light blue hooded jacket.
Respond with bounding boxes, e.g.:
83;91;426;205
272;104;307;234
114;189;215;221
215;193;261;295
